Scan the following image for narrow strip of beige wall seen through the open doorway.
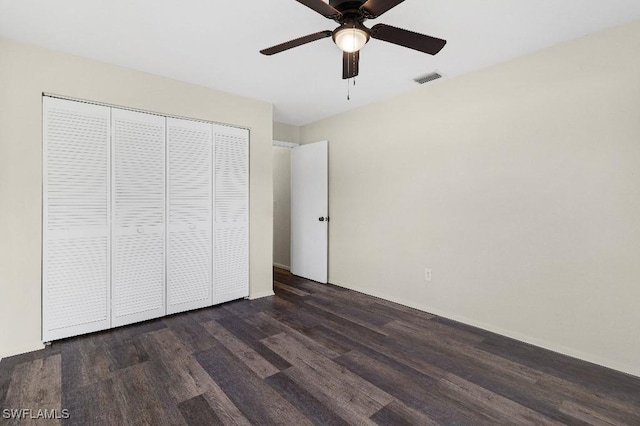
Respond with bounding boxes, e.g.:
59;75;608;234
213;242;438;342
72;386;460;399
273;146;291;269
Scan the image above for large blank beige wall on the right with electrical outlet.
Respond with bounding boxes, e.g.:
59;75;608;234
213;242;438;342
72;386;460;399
301;22;640;376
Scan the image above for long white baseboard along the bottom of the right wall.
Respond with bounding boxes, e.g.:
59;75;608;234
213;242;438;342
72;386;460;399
330;280;640;377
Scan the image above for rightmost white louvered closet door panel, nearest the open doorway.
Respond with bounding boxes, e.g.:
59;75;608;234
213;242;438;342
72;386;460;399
213;125;249;303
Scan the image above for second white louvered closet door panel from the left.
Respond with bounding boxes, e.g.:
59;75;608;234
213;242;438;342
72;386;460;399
111;108;165;327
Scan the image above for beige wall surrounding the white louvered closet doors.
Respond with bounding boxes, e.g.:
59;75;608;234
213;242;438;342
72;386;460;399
0;40;273;357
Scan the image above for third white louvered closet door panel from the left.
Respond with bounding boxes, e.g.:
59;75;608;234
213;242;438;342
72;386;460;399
167;118;213;314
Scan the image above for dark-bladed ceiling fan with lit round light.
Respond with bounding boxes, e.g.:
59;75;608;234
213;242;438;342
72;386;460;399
260;0;447;79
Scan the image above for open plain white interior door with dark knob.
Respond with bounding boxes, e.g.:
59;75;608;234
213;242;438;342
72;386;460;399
291;141;329;283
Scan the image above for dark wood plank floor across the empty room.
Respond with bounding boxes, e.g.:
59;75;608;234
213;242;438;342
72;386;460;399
0;270;640;425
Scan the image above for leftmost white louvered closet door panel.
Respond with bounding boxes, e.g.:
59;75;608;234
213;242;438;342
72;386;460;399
42;97;110;342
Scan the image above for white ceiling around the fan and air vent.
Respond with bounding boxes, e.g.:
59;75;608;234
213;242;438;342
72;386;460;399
0;0;640;125
